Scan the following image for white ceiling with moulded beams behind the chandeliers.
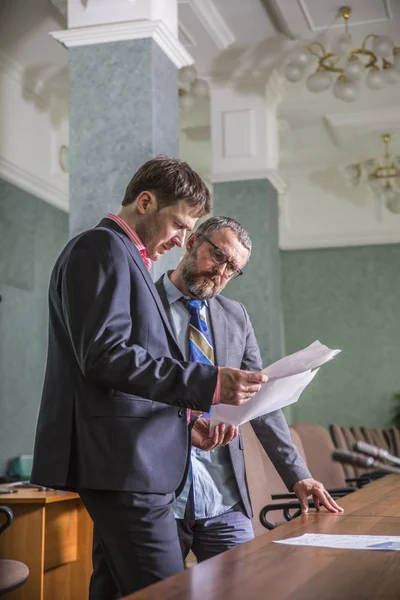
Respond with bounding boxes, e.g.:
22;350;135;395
0;0;400;172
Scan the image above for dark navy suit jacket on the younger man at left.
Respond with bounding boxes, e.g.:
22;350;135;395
31;219;217;493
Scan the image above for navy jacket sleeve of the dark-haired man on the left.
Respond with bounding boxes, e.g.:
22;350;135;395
59;229;218;411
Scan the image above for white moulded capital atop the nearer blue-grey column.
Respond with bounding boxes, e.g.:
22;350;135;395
50;0;194;69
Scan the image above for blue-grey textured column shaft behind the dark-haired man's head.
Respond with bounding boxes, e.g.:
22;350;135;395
69;39;179;276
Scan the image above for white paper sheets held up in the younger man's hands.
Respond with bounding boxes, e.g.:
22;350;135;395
210;341;340;431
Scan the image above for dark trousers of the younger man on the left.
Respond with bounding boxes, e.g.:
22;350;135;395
79;489;183;600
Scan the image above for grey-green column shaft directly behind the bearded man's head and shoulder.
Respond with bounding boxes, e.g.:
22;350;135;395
213;179;282;365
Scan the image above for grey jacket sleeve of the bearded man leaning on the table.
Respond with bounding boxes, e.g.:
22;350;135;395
241;307;311;490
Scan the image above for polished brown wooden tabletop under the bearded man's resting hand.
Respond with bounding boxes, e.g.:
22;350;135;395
127;475;400;600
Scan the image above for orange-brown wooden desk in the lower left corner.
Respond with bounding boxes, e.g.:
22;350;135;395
0;489;93;600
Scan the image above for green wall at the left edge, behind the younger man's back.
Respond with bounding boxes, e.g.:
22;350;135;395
0;181;68;473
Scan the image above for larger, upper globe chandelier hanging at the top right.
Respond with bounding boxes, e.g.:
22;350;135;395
284;6;400;102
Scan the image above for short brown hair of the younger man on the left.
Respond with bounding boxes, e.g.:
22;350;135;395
122;155;211;217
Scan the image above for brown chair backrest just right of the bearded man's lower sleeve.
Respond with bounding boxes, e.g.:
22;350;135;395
292;423;346;488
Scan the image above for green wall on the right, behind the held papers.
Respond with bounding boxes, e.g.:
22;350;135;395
281;245;400;427
